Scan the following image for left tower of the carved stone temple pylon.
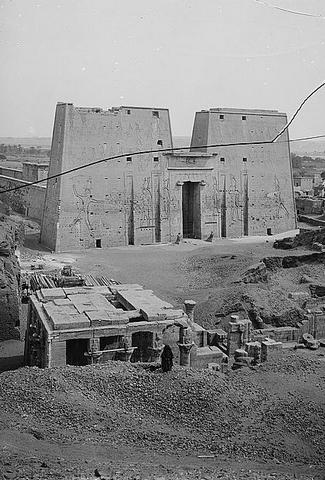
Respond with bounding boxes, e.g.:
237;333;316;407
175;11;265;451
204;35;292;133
41;104;172;251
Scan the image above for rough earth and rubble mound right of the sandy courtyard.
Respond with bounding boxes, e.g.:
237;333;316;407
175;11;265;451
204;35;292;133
187;250;325;329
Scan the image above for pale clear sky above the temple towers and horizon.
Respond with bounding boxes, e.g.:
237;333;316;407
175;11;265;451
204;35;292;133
0;0;325;138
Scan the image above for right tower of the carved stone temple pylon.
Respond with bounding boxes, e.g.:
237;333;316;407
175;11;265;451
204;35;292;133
191;108;296;237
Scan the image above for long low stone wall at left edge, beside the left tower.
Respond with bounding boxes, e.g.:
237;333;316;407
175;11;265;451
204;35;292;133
0;175;46;221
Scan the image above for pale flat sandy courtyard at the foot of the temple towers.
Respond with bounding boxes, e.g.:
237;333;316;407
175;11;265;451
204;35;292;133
21;231;297;306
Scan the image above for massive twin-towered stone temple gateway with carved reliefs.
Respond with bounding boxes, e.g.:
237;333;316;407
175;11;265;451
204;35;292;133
41;103;296;251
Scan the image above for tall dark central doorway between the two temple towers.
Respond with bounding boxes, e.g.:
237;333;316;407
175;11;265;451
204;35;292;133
182;182;201;238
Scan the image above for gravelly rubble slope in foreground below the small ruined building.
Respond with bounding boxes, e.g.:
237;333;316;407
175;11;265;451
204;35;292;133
0;352;325;478
